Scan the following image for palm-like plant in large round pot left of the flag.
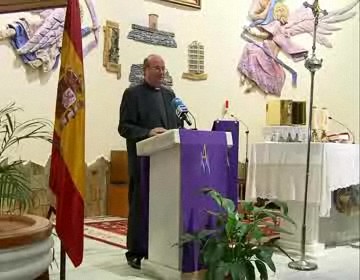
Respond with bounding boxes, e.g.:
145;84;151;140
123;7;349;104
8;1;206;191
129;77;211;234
0;103;53;279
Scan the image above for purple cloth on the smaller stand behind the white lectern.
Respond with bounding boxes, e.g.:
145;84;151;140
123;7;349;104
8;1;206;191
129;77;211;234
212;120;239;205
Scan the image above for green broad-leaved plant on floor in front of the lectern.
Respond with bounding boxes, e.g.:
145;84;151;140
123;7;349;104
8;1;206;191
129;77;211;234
180;189;295;280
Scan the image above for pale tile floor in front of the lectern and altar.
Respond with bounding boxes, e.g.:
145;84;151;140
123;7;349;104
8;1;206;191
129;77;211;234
50;235;360;280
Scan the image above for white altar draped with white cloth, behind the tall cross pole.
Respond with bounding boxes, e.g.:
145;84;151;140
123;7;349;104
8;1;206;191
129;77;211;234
246;143;359;257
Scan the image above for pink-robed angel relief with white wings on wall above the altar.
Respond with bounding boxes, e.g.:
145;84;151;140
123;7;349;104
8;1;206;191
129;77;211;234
238;0;359;96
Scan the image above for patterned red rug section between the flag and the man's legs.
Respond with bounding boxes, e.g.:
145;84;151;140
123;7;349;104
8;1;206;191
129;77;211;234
84;216;127;249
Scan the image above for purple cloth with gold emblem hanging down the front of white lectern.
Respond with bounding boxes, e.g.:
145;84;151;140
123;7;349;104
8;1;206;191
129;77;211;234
180;129;229;272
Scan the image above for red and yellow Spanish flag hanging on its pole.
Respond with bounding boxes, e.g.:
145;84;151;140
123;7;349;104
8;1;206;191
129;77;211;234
49;0;85;267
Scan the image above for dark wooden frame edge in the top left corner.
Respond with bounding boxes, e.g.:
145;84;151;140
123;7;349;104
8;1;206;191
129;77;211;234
0;0;67;14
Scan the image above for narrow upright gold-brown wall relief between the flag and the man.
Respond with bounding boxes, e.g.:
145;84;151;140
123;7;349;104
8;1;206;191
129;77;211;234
103;20;121;80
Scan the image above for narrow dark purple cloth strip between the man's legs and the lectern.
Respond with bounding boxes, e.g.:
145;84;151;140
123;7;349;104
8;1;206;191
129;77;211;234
138;157;150;257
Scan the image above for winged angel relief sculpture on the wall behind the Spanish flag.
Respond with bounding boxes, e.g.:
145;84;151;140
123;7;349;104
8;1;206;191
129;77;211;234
0;0;100;72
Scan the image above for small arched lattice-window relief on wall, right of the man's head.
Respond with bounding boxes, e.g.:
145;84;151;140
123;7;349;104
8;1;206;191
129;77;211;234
182;41;207;81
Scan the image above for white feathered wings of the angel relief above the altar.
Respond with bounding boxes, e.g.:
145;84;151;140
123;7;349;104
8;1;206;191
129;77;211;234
283;0;359;48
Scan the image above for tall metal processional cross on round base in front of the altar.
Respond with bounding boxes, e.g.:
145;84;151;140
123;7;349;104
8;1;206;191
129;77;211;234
288;0;327;271
